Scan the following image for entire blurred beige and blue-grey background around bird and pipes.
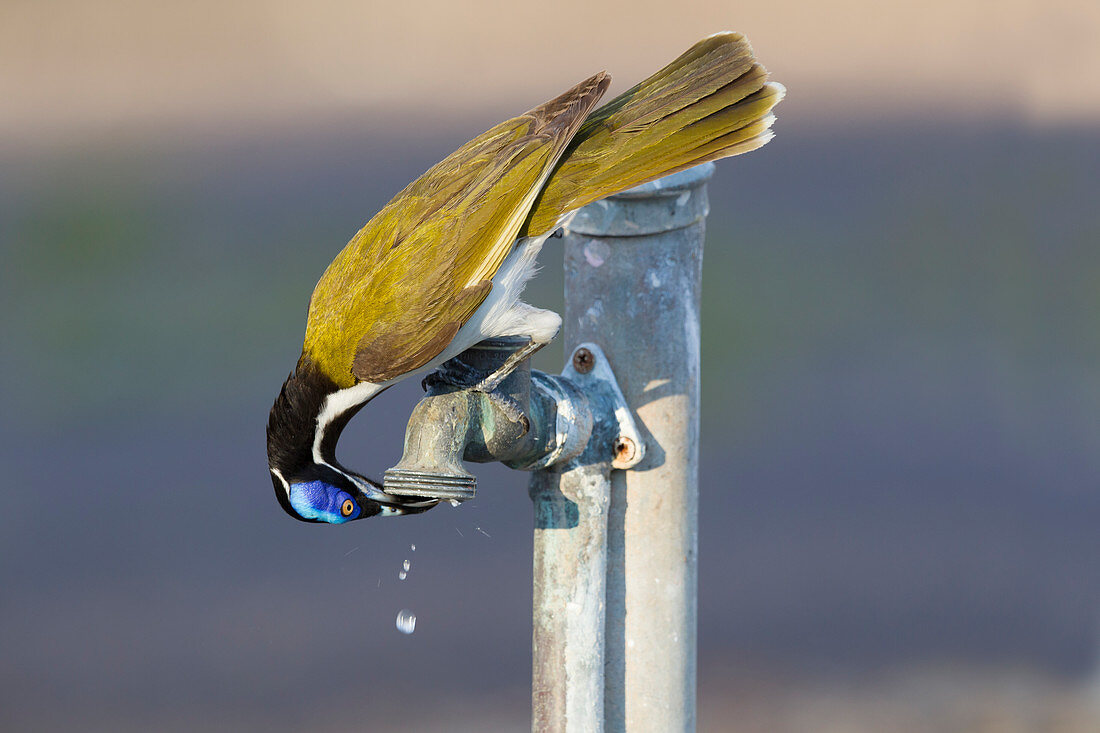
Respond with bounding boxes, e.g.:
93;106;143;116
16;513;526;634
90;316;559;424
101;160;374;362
0;0;1100;732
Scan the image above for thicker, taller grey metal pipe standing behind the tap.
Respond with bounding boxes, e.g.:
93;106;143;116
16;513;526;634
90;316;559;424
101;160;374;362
563;164;714;733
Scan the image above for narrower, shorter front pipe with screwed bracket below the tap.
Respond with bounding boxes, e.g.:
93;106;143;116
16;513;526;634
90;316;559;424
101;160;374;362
530;343;646;733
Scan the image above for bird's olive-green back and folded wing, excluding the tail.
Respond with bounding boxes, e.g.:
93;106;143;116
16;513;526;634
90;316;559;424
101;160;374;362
304;73;611;386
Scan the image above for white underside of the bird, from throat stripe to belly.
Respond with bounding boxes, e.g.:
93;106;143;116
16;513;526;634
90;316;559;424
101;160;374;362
314;214;573;471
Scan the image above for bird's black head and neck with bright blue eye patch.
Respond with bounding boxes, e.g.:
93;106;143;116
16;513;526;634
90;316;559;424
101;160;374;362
267;357;438;524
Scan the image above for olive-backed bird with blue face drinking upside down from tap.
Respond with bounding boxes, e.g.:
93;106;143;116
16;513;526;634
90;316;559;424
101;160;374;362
267;31;785;524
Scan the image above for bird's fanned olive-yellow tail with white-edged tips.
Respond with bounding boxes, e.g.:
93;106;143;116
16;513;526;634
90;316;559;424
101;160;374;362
521;32;785;236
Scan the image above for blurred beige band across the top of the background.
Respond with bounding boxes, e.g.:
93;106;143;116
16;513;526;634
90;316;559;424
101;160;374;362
0;0;1100;145
